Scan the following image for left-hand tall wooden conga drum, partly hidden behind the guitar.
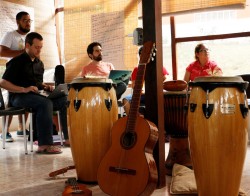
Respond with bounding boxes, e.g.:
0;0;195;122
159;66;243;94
68;78;118;183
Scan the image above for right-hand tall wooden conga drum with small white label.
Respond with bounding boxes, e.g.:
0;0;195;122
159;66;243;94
188;76;248;196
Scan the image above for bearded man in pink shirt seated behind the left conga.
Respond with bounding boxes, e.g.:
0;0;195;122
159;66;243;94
81;42;127;100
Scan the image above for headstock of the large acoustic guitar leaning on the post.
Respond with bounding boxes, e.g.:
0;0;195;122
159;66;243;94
139;41;156;64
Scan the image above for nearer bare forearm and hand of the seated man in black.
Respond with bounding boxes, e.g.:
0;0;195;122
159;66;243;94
0;79;38;93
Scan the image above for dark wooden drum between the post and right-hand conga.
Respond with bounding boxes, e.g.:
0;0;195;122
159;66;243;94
164;80;192;176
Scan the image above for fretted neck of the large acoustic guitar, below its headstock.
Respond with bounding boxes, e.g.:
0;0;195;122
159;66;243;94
126;63;146;130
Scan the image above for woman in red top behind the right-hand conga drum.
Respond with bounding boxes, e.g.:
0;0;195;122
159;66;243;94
184;44;222;82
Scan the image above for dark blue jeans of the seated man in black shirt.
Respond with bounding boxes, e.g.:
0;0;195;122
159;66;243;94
9;93;68;146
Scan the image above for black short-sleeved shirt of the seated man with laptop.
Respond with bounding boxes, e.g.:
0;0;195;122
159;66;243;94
2;52;44;89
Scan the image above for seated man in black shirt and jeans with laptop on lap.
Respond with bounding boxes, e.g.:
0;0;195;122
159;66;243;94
0;32;68;154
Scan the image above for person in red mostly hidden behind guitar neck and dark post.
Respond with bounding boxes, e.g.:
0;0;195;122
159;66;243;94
122;46;168;115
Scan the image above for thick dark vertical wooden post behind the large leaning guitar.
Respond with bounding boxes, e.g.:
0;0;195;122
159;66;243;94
142;0;166;188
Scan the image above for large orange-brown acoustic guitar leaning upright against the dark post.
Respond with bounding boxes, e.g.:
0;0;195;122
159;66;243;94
97;42;158;196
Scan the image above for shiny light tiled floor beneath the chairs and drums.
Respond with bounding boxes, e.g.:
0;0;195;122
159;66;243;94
0;134;250;196
